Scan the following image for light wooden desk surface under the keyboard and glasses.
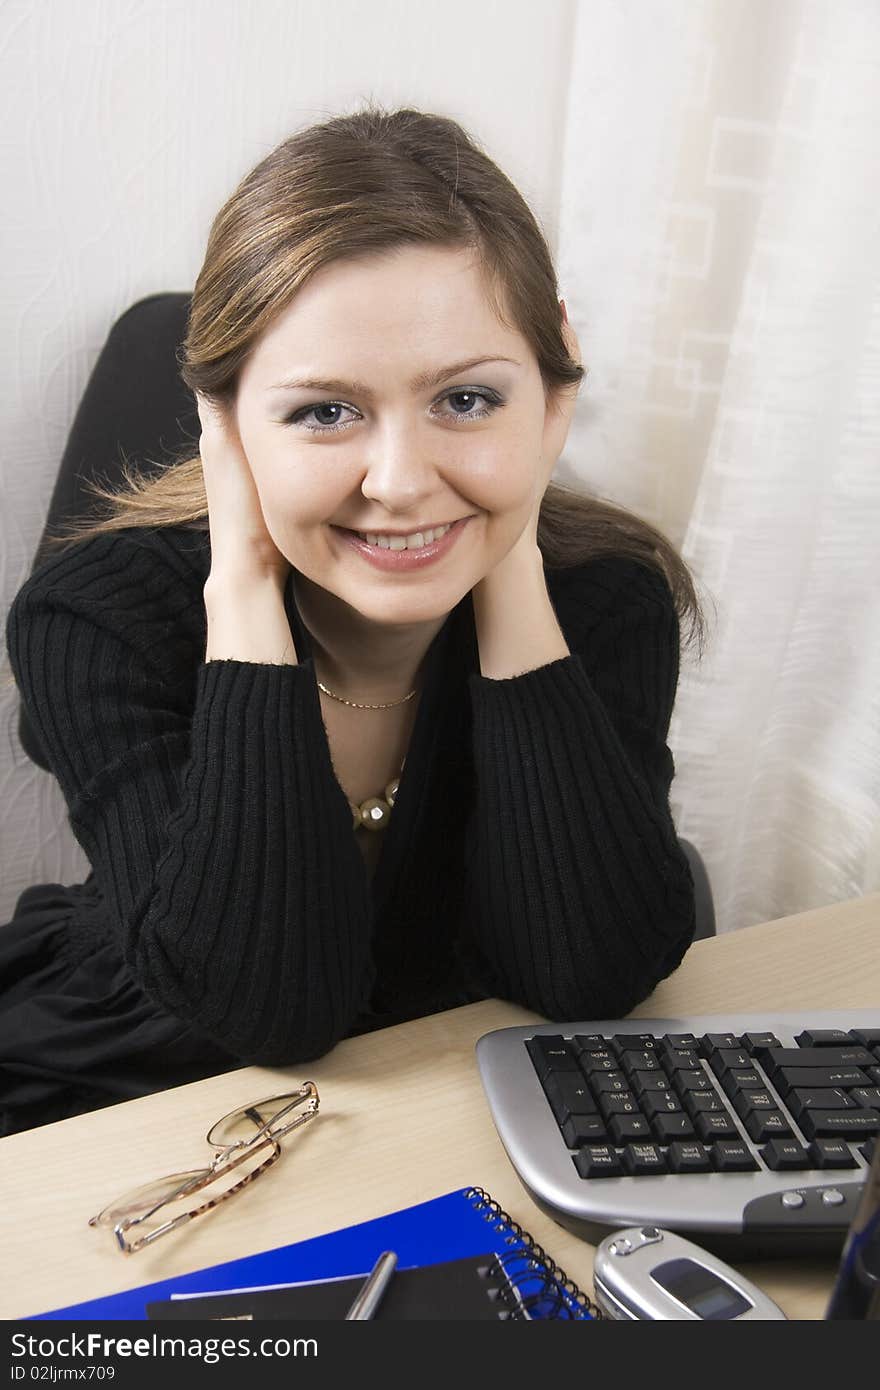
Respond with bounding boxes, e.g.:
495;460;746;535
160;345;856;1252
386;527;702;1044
0;894;880;1319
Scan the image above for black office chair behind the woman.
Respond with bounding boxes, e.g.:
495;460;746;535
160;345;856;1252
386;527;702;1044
18;293;715;941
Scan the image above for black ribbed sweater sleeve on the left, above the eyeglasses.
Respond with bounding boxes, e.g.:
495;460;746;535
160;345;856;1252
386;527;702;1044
7;534;374;1065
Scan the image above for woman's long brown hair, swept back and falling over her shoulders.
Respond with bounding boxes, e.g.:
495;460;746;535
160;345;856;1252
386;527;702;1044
44;103;705;655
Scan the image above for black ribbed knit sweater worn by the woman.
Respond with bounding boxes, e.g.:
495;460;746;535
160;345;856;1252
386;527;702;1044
7;527;694;1065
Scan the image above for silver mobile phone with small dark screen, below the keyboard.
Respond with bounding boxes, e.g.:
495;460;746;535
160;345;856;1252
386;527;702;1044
592;1226;785;1322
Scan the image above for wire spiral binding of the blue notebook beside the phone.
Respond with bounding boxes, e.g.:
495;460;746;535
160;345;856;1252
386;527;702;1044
463;1187;602;1321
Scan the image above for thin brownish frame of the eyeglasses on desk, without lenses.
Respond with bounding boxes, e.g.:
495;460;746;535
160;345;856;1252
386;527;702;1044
89;1081;320;1255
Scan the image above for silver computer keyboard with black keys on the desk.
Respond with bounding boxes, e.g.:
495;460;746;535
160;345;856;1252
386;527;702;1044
477;1009;880;1254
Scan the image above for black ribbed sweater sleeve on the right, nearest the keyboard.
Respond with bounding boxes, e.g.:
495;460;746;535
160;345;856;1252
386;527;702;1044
462;562;695;1022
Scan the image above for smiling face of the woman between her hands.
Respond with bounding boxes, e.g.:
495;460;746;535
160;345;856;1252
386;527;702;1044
236;246;562;624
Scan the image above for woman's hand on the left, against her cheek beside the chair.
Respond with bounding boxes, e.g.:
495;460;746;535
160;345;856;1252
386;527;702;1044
196;392;292;591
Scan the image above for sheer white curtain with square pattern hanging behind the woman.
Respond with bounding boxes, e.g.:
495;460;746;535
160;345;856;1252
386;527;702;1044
557;0;880;931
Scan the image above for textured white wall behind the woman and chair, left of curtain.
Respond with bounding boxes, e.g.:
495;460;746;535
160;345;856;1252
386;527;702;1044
0;0;576;923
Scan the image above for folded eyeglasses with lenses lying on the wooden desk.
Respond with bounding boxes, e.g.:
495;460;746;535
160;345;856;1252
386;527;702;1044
89;1081;320;1255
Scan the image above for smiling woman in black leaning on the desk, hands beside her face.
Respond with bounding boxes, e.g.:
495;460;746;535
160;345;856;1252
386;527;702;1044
0;107;701;1133
